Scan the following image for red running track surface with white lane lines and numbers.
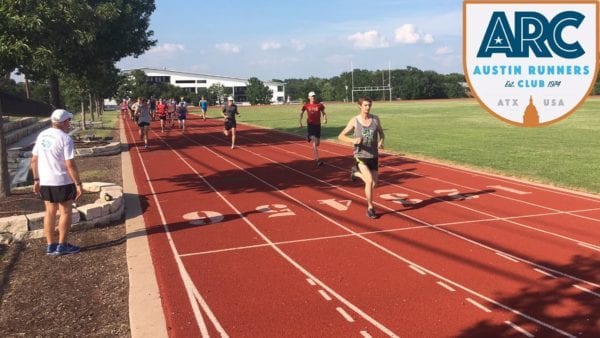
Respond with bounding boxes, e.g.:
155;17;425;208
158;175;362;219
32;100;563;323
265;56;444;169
125;116;600;337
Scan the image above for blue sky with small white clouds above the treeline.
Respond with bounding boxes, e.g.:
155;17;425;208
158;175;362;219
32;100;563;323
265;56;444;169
117;0;462;80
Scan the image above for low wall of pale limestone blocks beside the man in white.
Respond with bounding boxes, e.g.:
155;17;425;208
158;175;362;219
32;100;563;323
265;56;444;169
0;182;125;244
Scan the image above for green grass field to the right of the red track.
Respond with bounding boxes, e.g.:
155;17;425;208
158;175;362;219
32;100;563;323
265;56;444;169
236;98;600;193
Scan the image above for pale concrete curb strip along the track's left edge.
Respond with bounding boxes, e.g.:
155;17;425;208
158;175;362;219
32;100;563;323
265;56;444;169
120;115;169;338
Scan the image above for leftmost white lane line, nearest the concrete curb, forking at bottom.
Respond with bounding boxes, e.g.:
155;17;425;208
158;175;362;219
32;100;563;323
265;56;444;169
128;124;223;337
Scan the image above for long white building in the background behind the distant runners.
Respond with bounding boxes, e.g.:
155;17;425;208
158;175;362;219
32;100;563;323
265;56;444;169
125;68;285;103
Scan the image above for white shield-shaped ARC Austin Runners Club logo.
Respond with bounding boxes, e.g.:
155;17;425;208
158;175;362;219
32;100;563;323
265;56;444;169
463;0;599;127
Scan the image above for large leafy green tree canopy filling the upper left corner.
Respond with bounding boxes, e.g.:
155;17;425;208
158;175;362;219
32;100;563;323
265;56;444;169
0;0;156;107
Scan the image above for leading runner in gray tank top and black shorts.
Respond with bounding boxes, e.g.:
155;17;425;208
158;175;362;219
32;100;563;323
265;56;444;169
338;98;385;218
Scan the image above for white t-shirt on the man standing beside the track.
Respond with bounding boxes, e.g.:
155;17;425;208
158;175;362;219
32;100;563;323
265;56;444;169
32;128;75;186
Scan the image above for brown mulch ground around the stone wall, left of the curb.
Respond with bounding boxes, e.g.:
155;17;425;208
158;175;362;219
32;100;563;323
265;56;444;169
0;141;130;337
